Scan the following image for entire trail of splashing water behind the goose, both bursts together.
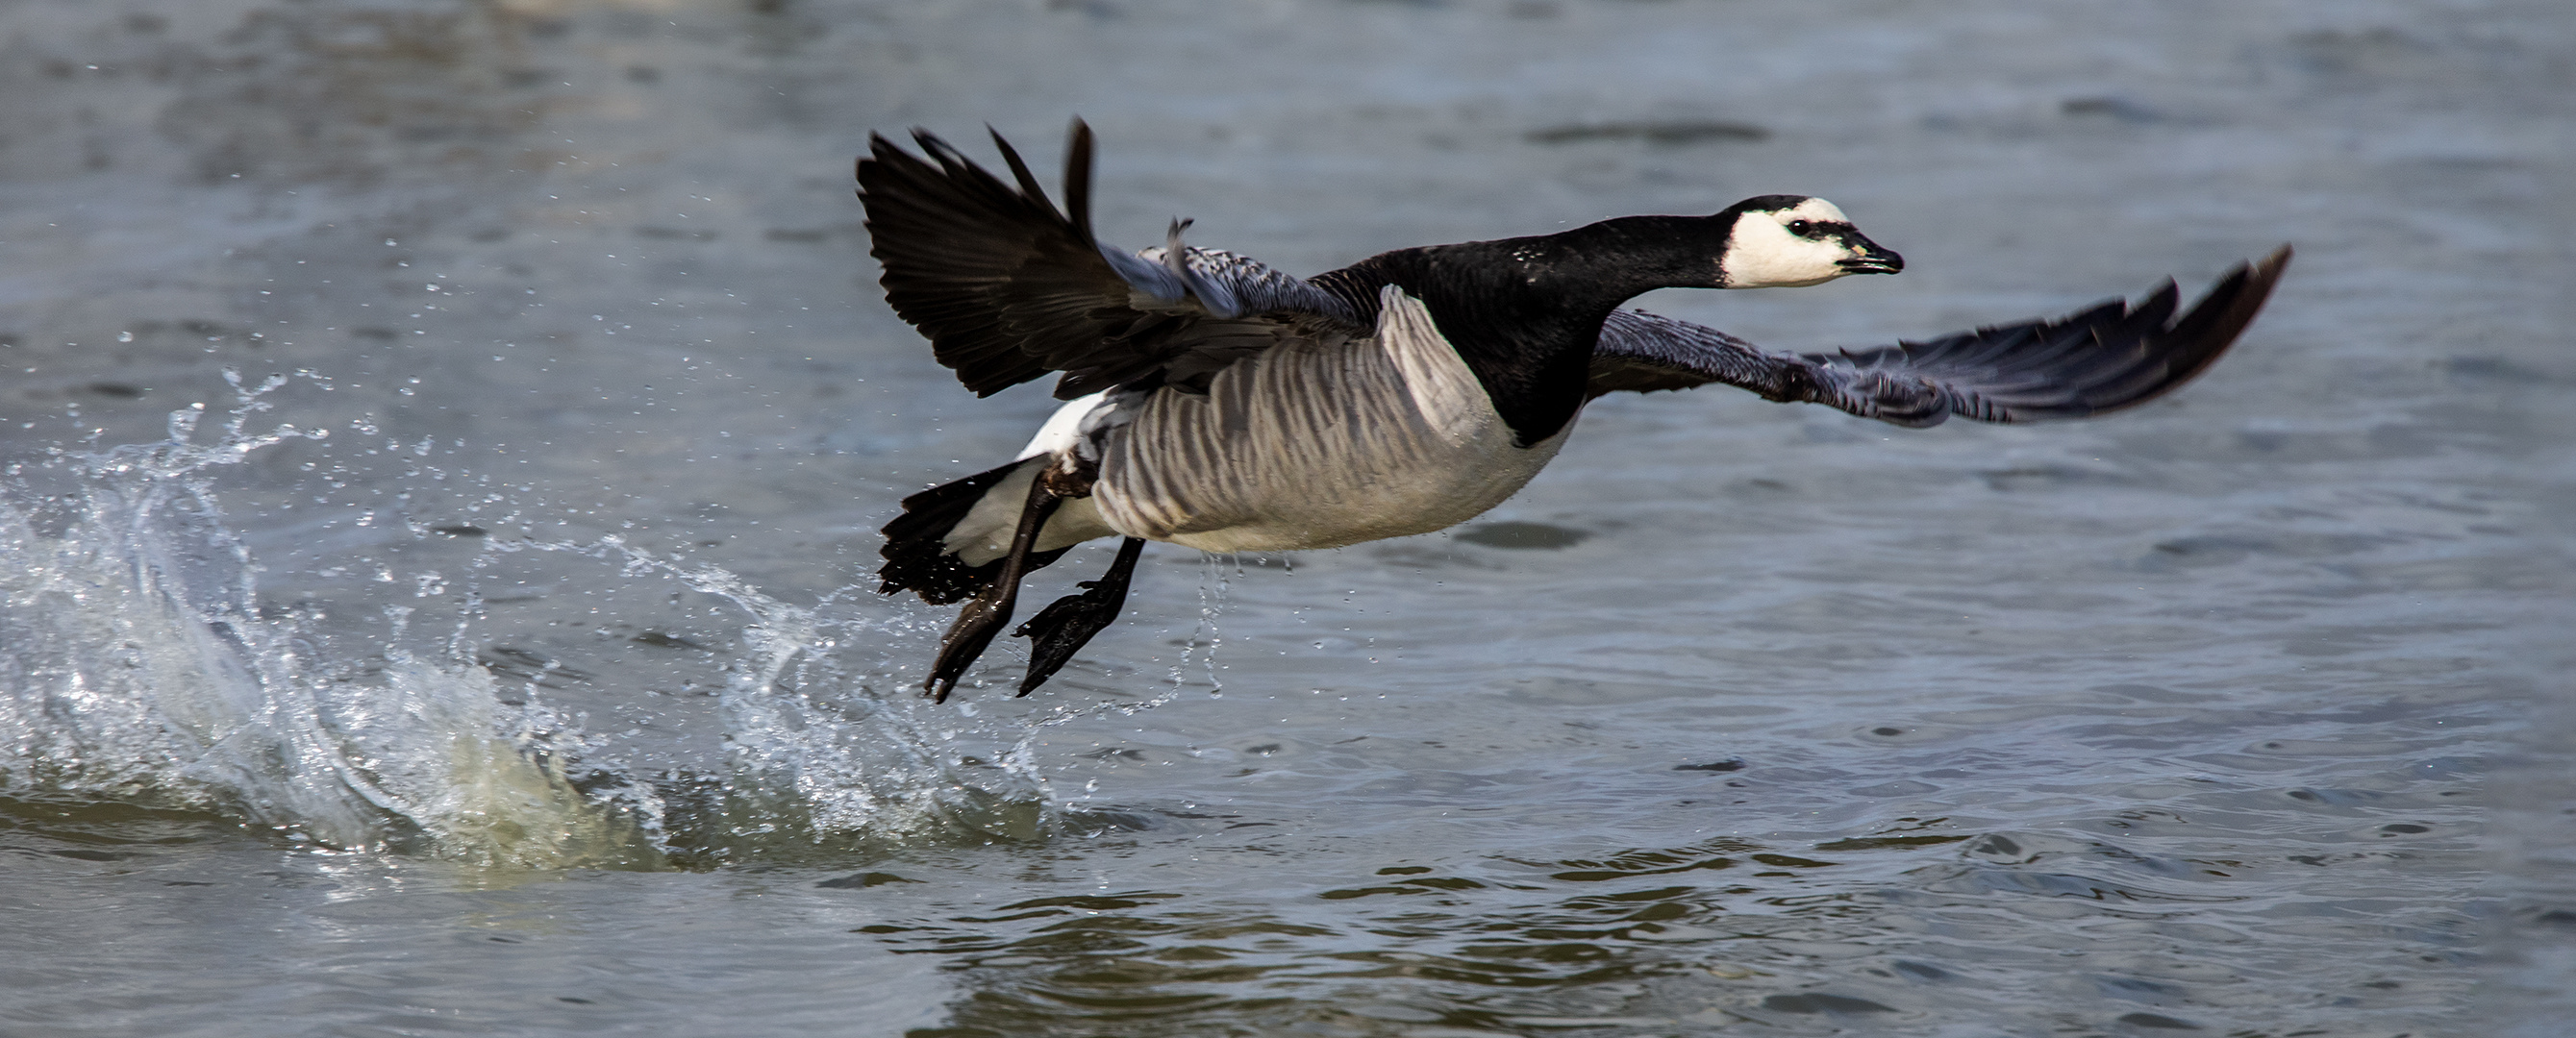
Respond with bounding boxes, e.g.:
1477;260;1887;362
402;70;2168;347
0;374;1224;868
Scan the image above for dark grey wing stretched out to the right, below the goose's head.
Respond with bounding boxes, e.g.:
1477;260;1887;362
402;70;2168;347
1589;245;2290;428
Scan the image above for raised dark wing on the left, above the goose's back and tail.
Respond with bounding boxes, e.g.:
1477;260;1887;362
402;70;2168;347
858;118;1368;399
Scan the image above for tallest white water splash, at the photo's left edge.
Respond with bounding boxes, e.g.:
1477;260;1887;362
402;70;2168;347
0;371;657;868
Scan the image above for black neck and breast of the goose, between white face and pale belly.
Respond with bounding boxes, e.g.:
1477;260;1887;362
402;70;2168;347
1312;213;1734;446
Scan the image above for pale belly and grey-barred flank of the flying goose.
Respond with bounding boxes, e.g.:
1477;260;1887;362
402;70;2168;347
1092;285;1574;551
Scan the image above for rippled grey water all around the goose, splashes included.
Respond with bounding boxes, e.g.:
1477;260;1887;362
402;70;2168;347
0;0;2576;1038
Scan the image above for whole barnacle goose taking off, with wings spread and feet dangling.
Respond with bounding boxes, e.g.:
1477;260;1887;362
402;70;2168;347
858;118;2290;701
